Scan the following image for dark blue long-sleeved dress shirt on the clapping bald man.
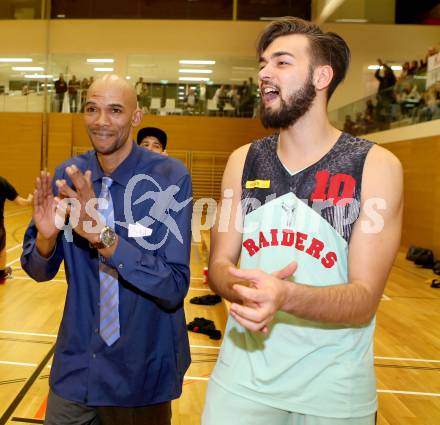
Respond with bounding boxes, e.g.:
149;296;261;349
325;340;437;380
21;143;192;407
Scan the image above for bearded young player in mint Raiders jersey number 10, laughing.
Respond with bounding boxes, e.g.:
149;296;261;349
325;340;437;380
202;17;402;425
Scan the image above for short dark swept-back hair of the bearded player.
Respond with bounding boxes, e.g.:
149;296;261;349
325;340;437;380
257;16;350;100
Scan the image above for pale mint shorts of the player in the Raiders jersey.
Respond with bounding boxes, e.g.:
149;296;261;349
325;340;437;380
201;379;375;425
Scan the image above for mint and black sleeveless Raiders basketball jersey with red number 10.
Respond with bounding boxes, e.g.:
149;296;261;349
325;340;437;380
212;133;377;418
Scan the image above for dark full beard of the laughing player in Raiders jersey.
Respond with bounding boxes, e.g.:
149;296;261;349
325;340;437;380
260;74;316;129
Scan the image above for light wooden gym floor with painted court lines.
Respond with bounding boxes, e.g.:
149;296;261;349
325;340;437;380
0;205;440;425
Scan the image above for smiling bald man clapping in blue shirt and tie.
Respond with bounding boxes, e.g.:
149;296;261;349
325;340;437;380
21;75;192;425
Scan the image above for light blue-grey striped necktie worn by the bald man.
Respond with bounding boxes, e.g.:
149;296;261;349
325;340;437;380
99;177;120;346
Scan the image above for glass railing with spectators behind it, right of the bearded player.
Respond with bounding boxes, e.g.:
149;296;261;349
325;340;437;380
329;75;440;136
